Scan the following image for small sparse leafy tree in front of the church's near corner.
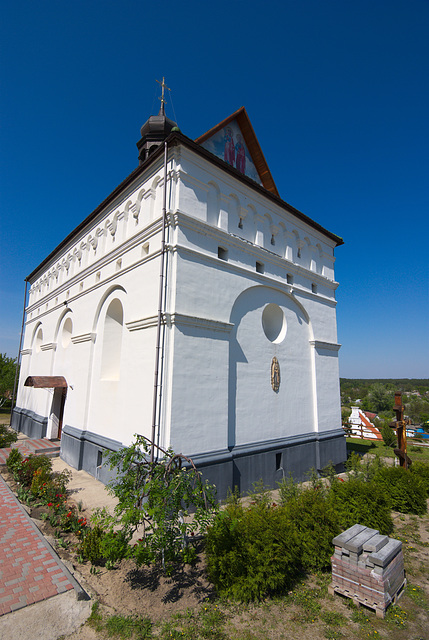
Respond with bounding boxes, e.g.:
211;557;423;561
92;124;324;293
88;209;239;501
96;435;216;569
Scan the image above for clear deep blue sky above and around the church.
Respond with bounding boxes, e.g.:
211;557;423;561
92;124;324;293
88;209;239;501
0;0;429;378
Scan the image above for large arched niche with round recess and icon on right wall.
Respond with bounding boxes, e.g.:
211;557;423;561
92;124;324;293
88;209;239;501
228;286;315;456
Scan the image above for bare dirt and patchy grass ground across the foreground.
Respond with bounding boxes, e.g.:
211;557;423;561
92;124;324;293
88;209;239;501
2;460;429;640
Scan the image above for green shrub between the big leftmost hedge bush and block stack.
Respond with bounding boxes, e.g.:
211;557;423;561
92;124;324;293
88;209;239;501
285;487;340;571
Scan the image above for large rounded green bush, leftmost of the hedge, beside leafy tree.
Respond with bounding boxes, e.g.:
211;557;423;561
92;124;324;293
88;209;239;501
206;504;299;602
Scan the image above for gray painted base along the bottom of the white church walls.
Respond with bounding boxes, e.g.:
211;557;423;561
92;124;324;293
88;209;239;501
12;409;347;500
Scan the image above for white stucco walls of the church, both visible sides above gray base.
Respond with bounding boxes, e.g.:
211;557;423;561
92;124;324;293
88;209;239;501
17;136;341;464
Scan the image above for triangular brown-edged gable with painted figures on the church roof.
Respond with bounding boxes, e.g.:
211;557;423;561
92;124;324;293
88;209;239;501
195;107;279;196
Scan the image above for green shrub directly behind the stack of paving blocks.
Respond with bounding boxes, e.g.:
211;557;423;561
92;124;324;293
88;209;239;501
330;477;393;535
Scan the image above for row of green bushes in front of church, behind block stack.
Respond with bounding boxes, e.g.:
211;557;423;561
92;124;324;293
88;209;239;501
206;460;429;601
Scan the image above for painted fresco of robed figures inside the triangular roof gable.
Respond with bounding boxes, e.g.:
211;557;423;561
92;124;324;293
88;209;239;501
201;120;262;184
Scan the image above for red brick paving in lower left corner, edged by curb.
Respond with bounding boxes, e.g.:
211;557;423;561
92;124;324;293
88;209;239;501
0;476;84;616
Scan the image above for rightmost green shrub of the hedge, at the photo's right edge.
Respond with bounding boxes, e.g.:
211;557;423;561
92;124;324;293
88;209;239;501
375;467;427;515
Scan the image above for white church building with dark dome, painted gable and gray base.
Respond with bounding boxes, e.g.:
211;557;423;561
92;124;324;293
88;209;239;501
12;102;346;497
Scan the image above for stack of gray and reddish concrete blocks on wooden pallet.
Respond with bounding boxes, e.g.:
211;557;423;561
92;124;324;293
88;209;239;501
328;524;406;618
